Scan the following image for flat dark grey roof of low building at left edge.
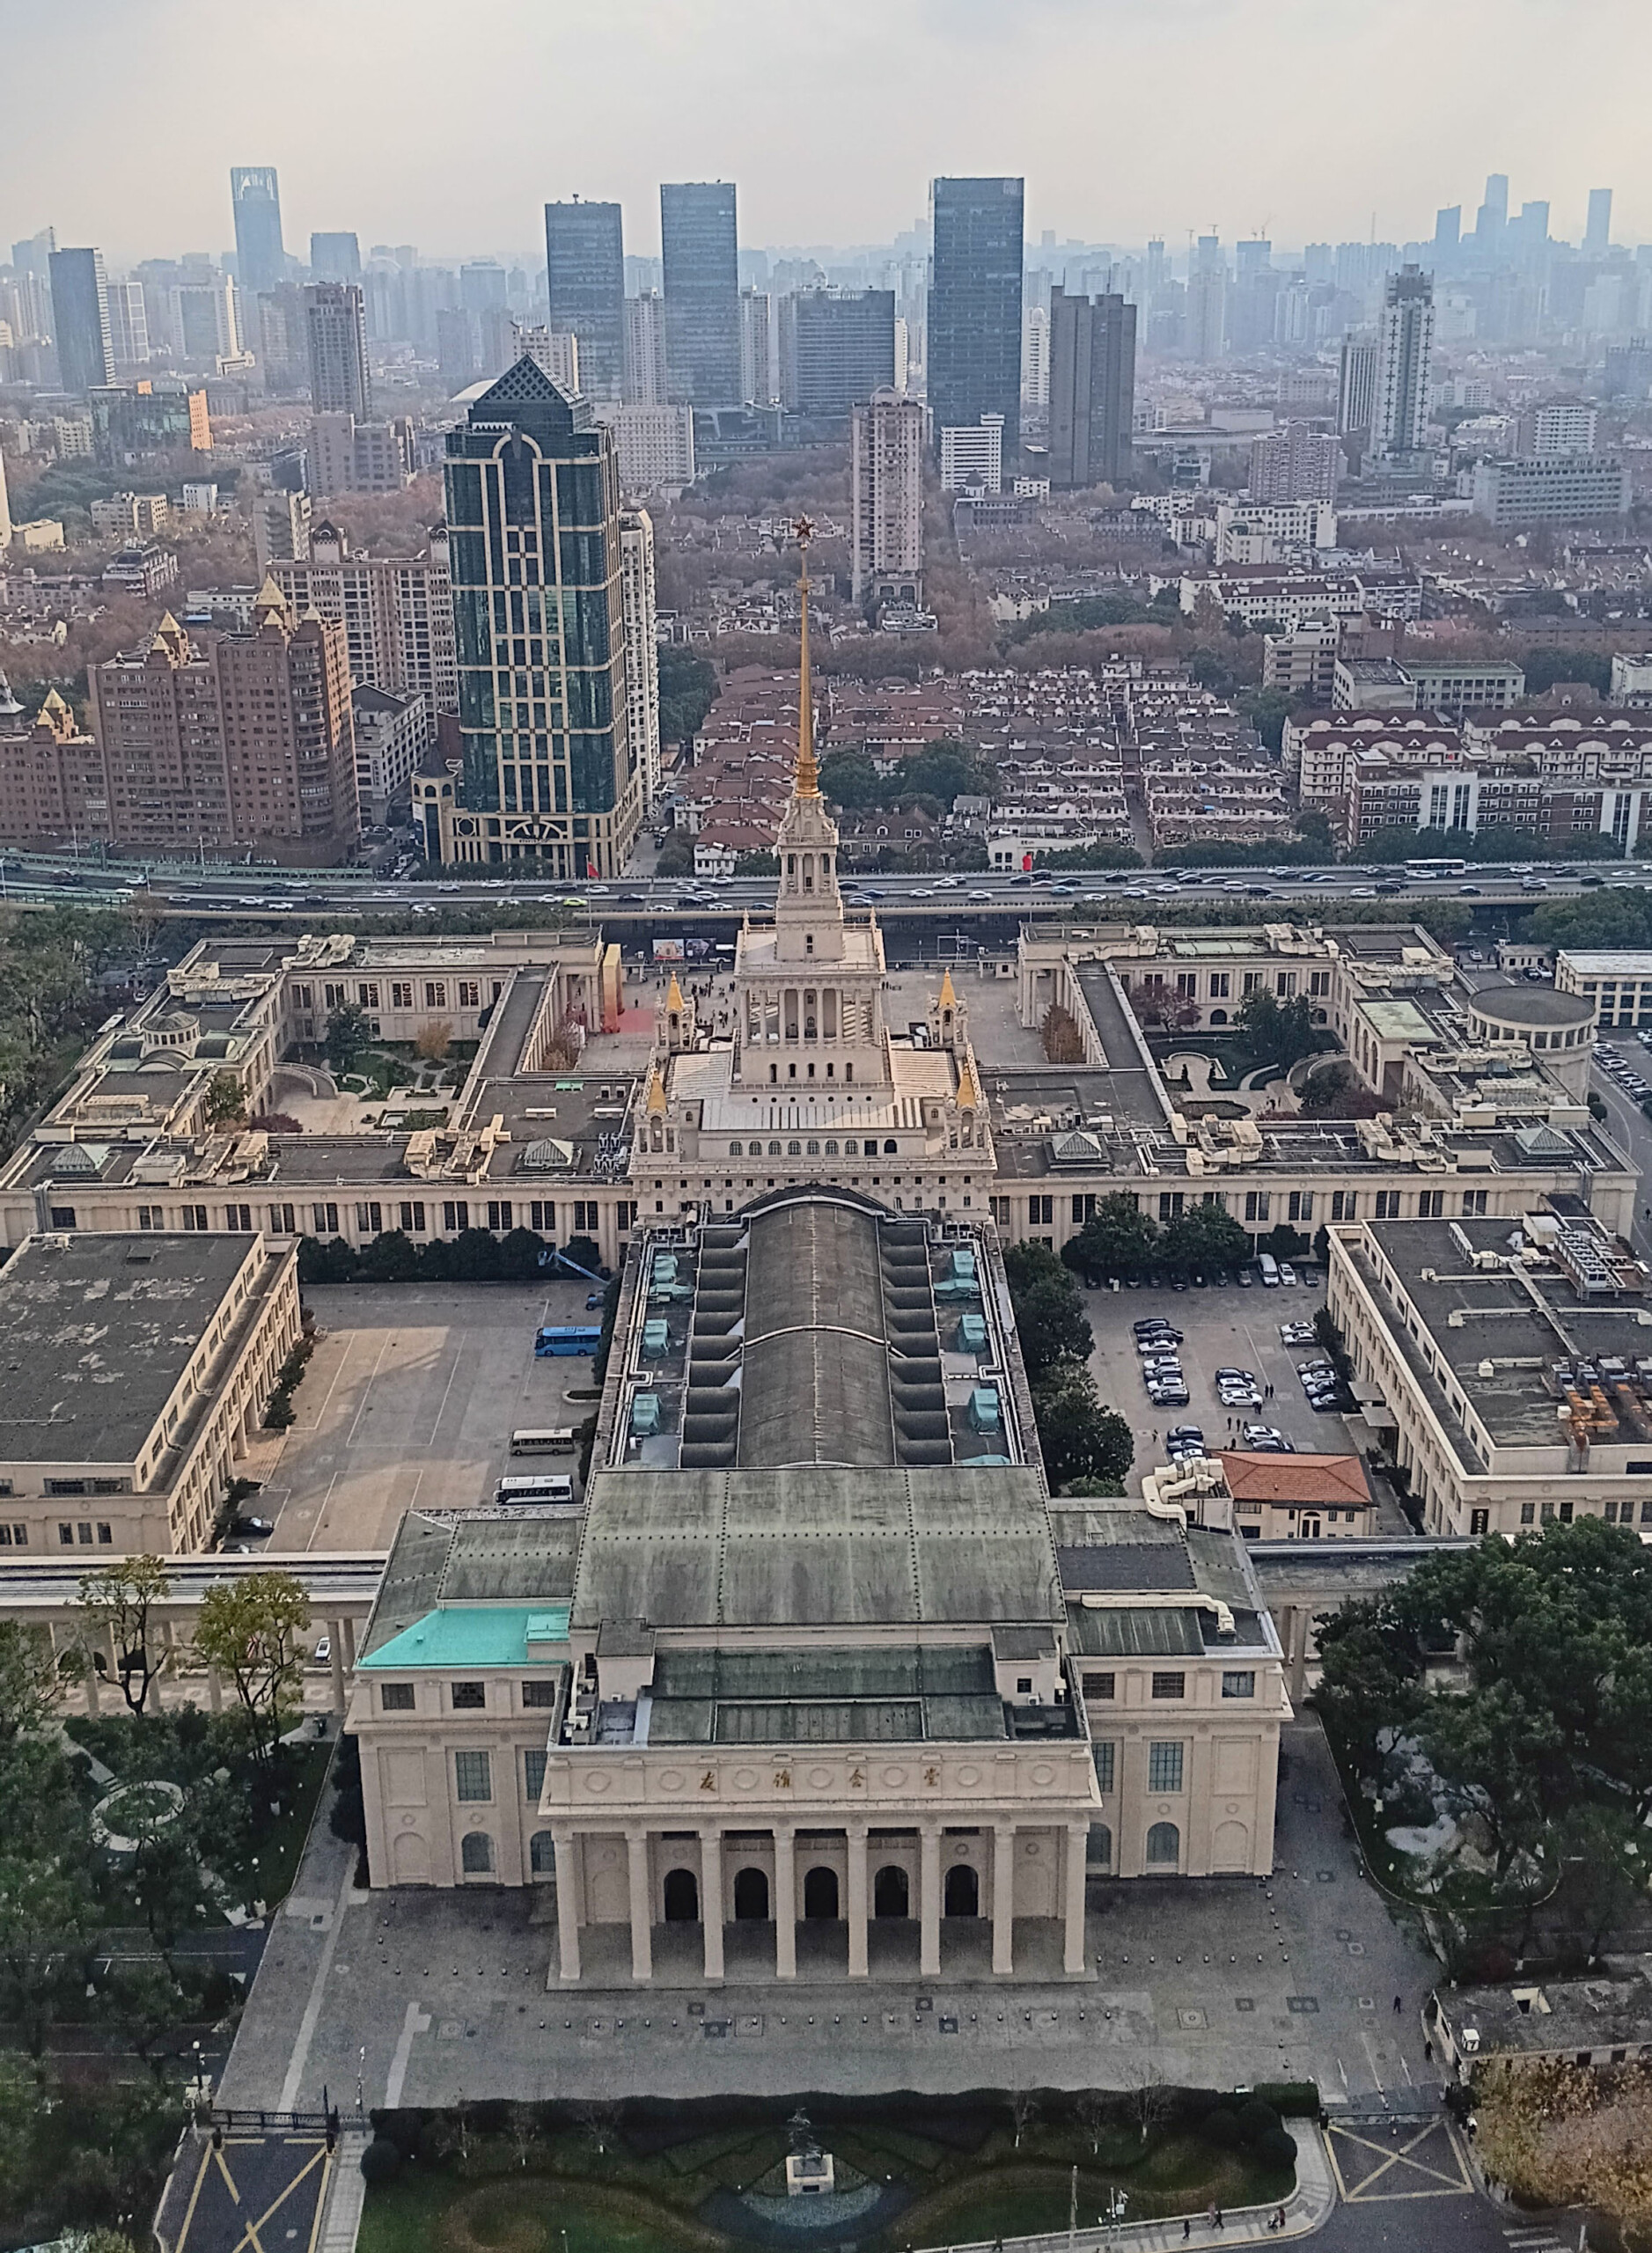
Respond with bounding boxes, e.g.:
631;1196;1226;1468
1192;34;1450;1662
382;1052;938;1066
0;1235;253;1462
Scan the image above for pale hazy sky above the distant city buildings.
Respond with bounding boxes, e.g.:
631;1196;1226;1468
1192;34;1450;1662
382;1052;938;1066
0;0;1652;266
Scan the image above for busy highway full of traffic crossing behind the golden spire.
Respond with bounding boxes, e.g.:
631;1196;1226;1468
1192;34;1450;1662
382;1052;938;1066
0;854;1652;930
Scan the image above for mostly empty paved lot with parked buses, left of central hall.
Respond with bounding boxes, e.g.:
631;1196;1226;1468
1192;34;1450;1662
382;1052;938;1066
246;1282;599;1552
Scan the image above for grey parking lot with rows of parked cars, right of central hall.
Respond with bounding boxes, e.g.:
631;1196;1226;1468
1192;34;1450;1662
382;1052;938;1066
1084;1271;1359;1473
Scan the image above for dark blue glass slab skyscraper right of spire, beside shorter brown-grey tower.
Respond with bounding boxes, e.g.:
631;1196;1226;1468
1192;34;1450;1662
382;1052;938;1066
926;178;1024;459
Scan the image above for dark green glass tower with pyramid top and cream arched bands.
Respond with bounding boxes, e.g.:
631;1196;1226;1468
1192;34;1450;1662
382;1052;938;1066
444;358;642;877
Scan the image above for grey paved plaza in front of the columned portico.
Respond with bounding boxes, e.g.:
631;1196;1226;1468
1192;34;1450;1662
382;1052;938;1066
221;1719;1438;2111
